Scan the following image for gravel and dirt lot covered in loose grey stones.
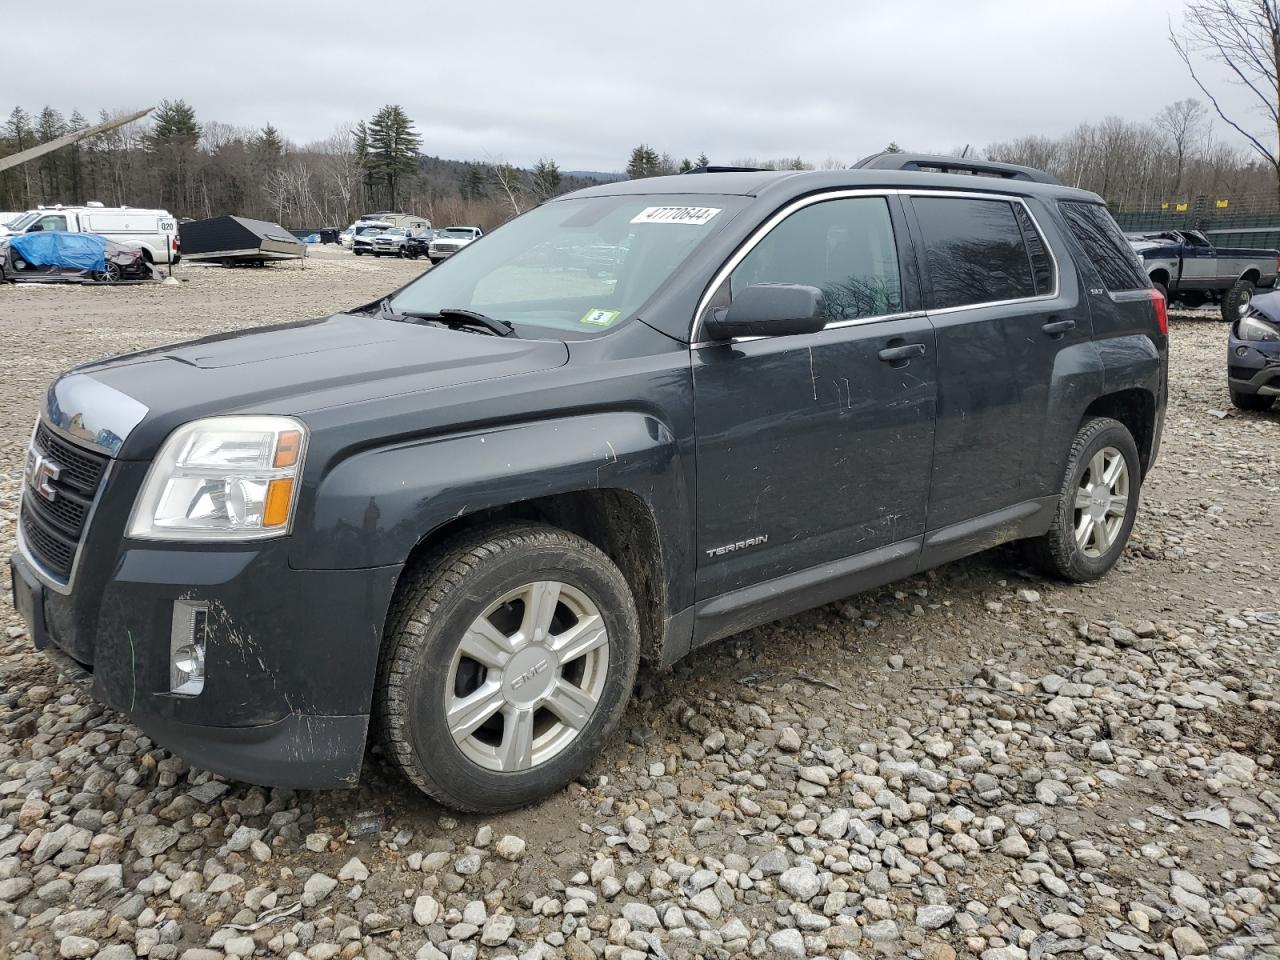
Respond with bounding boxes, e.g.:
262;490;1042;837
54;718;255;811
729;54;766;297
0;252;1280;960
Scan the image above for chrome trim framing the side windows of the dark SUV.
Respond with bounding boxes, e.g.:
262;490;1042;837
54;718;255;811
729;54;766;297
689;187;1062;349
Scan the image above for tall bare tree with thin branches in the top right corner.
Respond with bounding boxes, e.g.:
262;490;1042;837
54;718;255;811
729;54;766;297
1169;0;1280;192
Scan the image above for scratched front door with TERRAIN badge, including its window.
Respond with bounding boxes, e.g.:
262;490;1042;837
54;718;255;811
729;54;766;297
692;195;937;599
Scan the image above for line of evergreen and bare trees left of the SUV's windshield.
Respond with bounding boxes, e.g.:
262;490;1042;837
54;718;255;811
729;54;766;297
0;100;588;228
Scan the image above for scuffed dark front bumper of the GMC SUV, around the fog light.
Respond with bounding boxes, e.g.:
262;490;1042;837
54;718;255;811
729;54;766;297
10;461;401;787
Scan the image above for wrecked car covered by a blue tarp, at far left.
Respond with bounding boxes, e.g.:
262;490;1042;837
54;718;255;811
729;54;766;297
0;232;154;283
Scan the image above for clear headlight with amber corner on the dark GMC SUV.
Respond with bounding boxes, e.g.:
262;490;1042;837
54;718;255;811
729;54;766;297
129;416;307;540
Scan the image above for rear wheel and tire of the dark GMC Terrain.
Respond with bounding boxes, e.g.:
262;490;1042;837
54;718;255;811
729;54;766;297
1027;417;1142;582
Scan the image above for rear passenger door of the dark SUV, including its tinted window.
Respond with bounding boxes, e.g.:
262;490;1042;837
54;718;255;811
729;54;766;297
910;192;1089;535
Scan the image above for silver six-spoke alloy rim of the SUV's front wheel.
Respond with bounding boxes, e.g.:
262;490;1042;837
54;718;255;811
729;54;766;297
444;580;609;773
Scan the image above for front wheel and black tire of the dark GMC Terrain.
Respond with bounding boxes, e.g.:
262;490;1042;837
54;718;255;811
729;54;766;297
376;525;640;813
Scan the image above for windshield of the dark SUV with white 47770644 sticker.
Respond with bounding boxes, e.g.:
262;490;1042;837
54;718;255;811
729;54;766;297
390;195;746;338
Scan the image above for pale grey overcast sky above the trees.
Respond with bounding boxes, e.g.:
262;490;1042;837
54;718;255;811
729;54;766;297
0;0;1261;170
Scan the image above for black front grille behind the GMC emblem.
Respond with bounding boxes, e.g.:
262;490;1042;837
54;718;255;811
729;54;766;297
20;424;109;581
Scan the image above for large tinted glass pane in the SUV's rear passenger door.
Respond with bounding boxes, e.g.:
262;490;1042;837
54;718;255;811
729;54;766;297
911;197;1036;310
